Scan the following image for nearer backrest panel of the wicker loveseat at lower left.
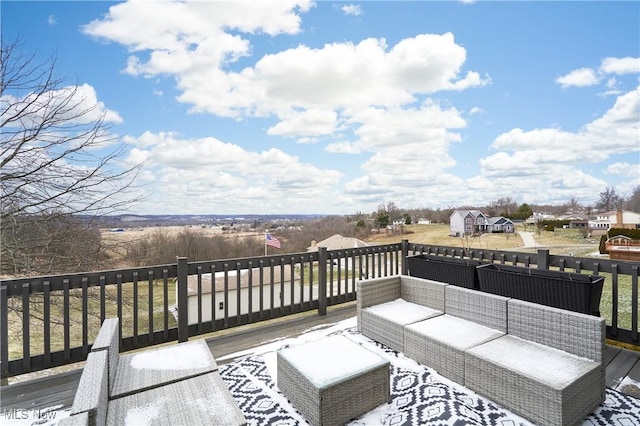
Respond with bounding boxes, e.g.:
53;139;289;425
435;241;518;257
71;351;109;426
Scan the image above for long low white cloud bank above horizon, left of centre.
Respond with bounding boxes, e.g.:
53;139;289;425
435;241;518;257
120;132;341;213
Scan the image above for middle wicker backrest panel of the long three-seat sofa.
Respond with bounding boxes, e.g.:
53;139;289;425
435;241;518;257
444;286;509;333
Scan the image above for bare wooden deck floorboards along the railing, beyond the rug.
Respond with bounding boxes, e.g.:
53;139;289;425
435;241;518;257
0;302;640;411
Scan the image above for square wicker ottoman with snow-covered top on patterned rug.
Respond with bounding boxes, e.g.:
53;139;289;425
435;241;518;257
277;336;390;425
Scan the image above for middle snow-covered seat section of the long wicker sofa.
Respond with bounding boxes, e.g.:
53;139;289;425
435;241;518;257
404;314;504;385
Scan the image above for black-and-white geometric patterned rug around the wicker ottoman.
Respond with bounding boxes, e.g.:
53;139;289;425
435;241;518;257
218;327;640;426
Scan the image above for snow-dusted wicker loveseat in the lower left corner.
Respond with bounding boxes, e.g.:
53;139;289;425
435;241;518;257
59;318;246;426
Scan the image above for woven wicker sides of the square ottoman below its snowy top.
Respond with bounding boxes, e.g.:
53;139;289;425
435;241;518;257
277;353;390;425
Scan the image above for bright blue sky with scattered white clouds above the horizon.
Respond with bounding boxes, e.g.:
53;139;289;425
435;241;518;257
0;0;640;214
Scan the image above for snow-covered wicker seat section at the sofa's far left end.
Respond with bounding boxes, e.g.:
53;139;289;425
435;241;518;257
360;299;443;352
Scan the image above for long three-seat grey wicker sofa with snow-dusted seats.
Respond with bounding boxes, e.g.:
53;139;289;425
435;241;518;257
357;275;605;425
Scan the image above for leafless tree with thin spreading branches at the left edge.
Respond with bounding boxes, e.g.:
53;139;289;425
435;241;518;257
0;41;139;275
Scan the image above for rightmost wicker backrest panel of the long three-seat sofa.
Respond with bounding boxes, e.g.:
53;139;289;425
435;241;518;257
508;299;606;363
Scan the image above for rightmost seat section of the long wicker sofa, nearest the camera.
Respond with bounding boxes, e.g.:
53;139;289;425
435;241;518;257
465;336;605;426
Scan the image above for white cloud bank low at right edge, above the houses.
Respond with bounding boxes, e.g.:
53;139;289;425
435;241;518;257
467;87;640;203
